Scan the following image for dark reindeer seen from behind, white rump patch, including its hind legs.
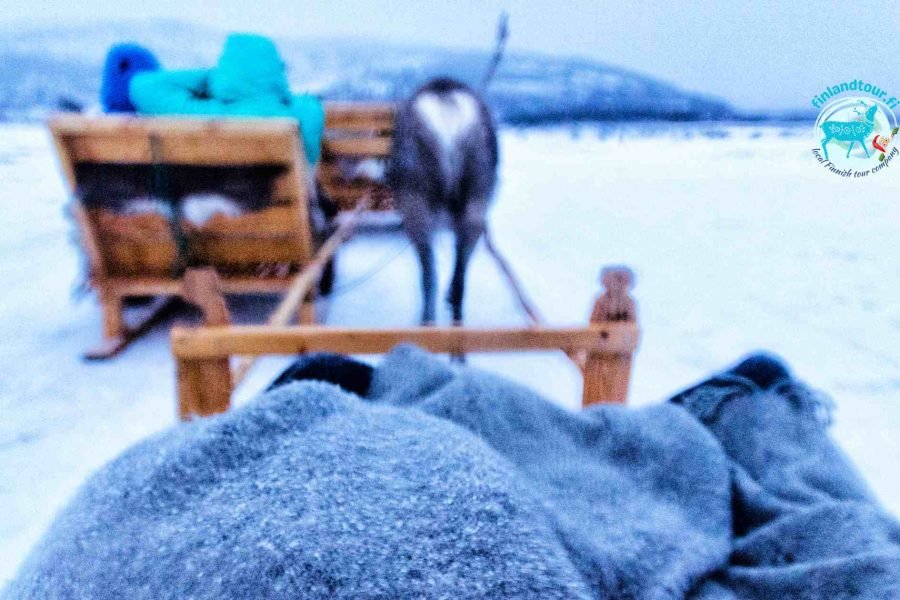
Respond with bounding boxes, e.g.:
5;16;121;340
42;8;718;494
387;78;498;325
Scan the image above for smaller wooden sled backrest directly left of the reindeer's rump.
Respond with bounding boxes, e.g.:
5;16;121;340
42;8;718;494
318;102;395;211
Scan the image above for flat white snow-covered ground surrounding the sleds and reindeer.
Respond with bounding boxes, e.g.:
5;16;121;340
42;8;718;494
0;125;900;586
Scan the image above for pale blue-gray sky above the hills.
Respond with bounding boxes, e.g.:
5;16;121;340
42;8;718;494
0;0;900;109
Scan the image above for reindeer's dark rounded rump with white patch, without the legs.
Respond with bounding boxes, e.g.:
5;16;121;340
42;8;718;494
388;78;498;213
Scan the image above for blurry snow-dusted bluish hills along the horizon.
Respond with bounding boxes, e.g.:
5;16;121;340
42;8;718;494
0;21;732;123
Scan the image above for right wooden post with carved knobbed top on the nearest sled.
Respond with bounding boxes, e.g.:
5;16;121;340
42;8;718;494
581;267;637;406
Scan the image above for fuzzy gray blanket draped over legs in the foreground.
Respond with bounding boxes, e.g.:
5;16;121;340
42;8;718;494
3;347;900;600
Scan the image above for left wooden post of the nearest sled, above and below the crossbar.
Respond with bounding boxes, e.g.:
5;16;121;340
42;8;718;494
176;267;232;421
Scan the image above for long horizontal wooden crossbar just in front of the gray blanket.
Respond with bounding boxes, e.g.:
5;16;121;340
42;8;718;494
171;323;639;359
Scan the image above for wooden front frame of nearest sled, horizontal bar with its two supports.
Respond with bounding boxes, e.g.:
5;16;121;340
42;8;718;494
171;270;640;420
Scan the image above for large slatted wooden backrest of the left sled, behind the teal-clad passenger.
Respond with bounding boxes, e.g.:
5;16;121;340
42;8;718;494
50;115;313;277
